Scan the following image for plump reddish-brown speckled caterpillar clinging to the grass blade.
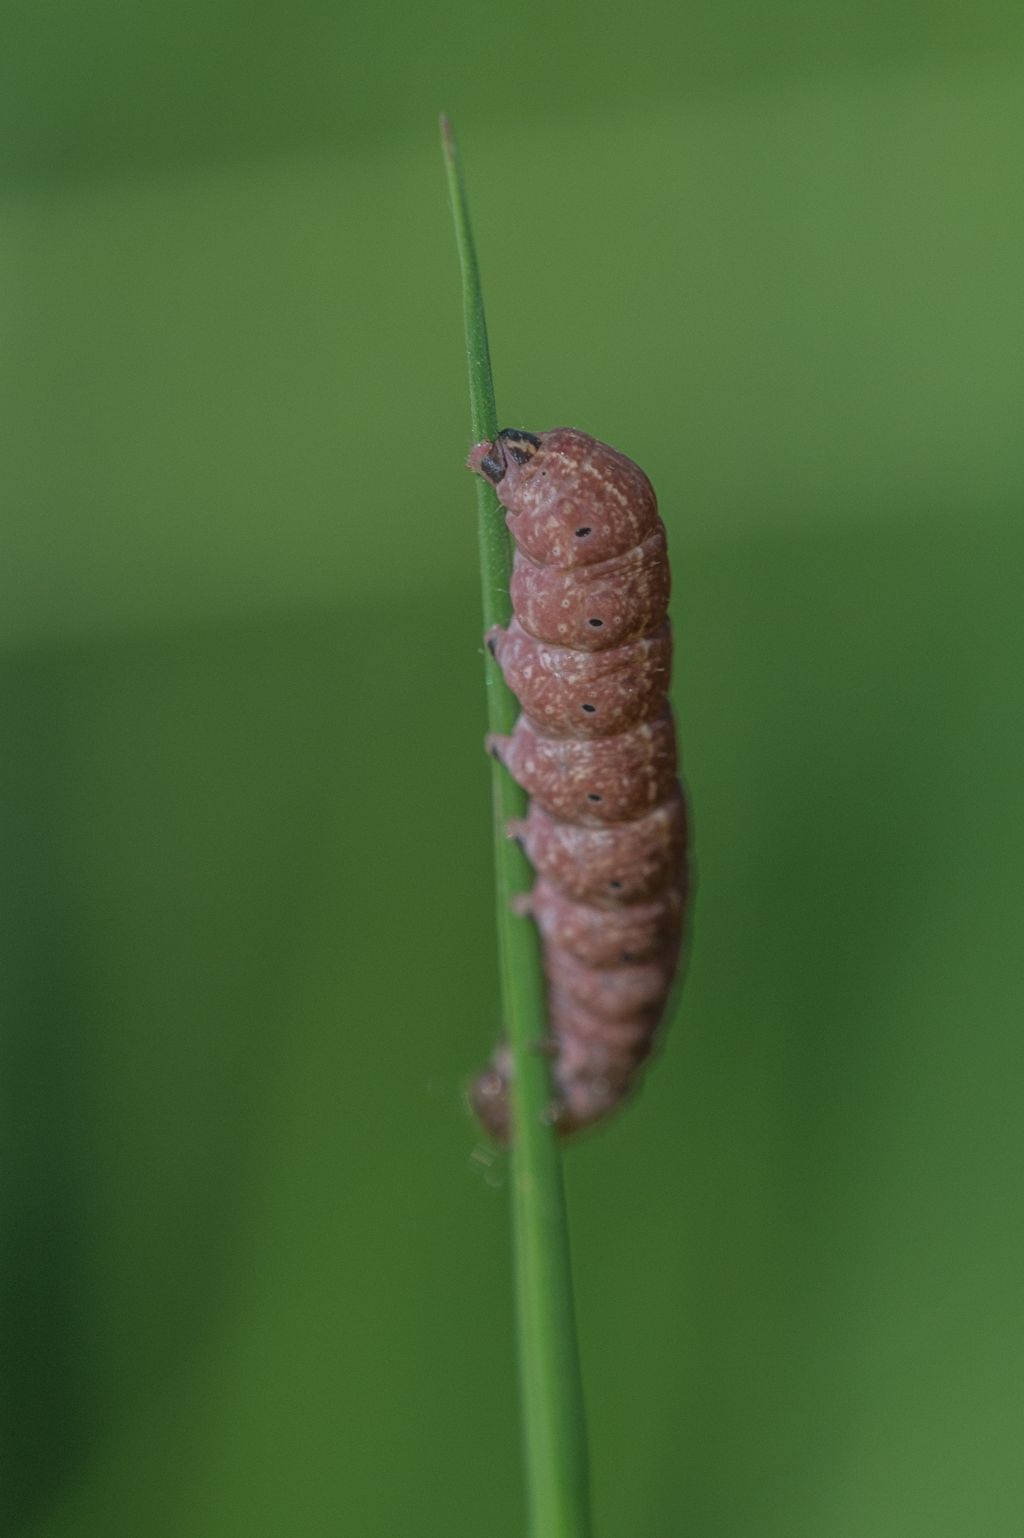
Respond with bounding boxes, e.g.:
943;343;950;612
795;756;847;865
467;428;689;1141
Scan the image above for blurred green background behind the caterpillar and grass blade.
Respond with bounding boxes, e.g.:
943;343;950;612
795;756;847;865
0;0;1024;1538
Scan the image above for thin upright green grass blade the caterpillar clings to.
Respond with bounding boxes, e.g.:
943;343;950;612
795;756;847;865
441;117;590;1538
